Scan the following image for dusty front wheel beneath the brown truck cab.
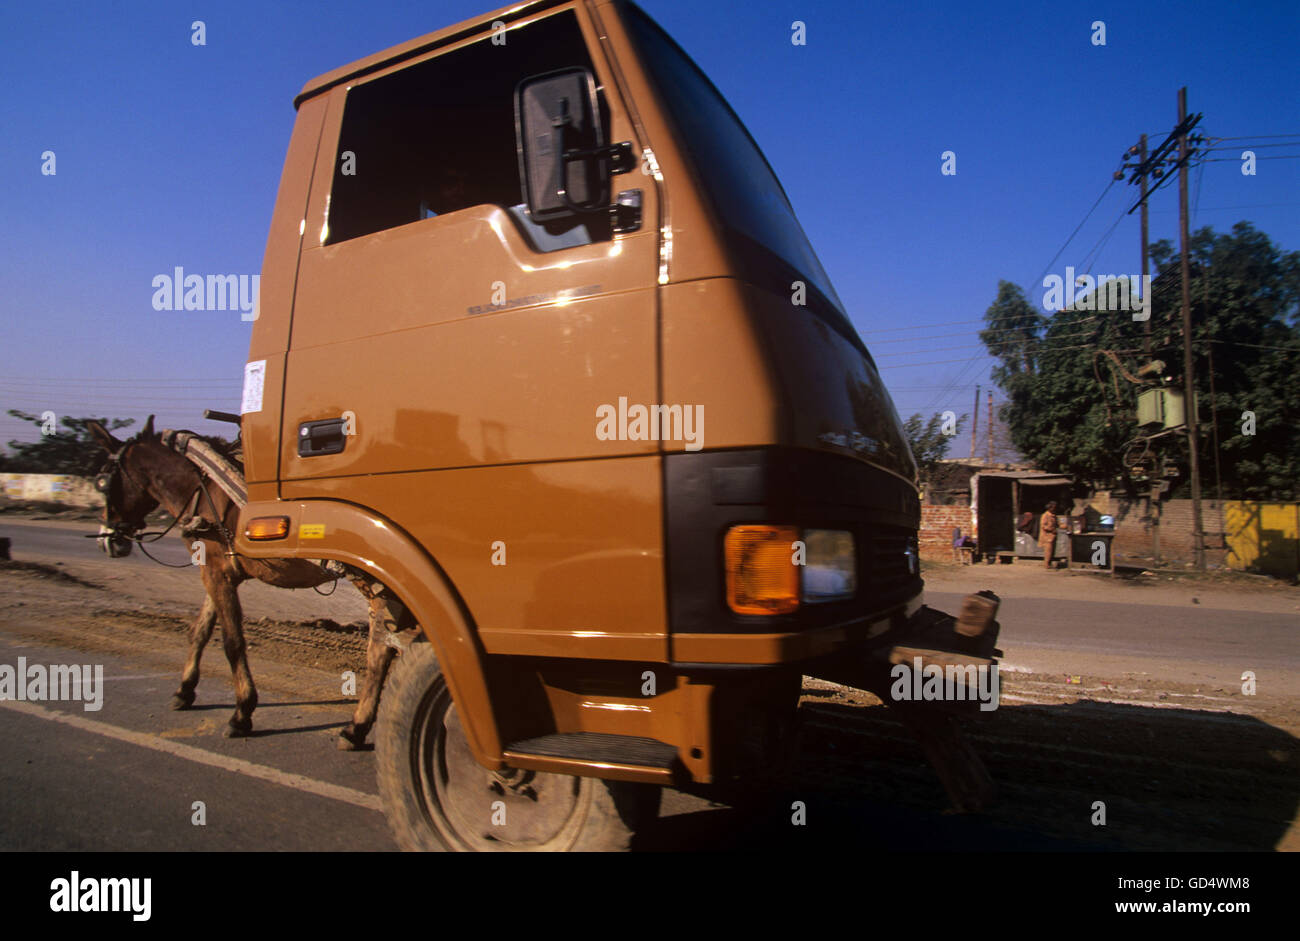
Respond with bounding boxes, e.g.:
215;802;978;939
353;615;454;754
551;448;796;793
374;642;662;851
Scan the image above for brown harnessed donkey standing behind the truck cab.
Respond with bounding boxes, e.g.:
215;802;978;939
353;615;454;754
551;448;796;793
87;415;413;751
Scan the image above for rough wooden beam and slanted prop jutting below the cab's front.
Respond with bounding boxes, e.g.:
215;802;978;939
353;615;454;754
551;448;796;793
809;591;1002;814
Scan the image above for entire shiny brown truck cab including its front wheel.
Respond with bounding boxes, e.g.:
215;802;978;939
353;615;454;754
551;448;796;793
237;0;946;849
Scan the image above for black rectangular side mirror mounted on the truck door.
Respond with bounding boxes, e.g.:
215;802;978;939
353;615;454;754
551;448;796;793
515;69;616;222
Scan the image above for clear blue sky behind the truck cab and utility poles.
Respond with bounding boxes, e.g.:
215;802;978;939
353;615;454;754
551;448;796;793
0;0;1300;452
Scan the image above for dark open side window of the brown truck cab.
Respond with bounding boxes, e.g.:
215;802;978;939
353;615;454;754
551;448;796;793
325;12;602;251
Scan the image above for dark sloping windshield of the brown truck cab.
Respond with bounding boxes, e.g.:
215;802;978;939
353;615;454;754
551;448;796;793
623;3;861;337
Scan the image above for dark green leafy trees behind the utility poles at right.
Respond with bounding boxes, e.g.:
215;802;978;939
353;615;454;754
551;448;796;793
980;222;1300;500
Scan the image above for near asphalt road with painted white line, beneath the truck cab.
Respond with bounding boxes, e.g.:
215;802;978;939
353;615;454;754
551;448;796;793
0;633;1086;851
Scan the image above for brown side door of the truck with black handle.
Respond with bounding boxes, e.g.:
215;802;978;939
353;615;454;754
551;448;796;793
280;9;666;658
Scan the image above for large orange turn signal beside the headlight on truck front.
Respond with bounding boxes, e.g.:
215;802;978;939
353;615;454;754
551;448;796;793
724;525;800;615
